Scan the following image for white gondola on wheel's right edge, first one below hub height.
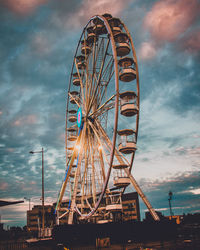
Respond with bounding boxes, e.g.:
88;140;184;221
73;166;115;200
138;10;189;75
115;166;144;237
118;129;137;154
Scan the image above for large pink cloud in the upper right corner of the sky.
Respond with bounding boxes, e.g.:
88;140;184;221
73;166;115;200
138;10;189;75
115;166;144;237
144;0;200;42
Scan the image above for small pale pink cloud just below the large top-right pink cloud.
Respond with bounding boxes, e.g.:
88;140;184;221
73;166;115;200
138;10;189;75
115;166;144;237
138;42;156;60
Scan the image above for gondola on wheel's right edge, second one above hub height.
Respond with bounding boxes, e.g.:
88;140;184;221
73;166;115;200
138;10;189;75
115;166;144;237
118;57;136;82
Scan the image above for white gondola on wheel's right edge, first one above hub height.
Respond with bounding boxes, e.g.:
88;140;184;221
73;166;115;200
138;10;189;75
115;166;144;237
119;91;138;117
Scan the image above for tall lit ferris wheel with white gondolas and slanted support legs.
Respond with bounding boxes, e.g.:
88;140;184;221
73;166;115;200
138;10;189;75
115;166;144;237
56;14;159;224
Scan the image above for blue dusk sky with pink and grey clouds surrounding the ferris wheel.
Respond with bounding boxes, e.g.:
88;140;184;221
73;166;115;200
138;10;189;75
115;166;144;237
0;0;200;226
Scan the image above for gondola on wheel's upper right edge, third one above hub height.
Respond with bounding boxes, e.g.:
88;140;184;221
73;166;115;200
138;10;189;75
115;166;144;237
114;32;131;56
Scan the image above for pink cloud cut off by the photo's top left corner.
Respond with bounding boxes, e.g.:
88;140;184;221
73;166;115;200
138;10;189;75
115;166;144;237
1;0;47;15
